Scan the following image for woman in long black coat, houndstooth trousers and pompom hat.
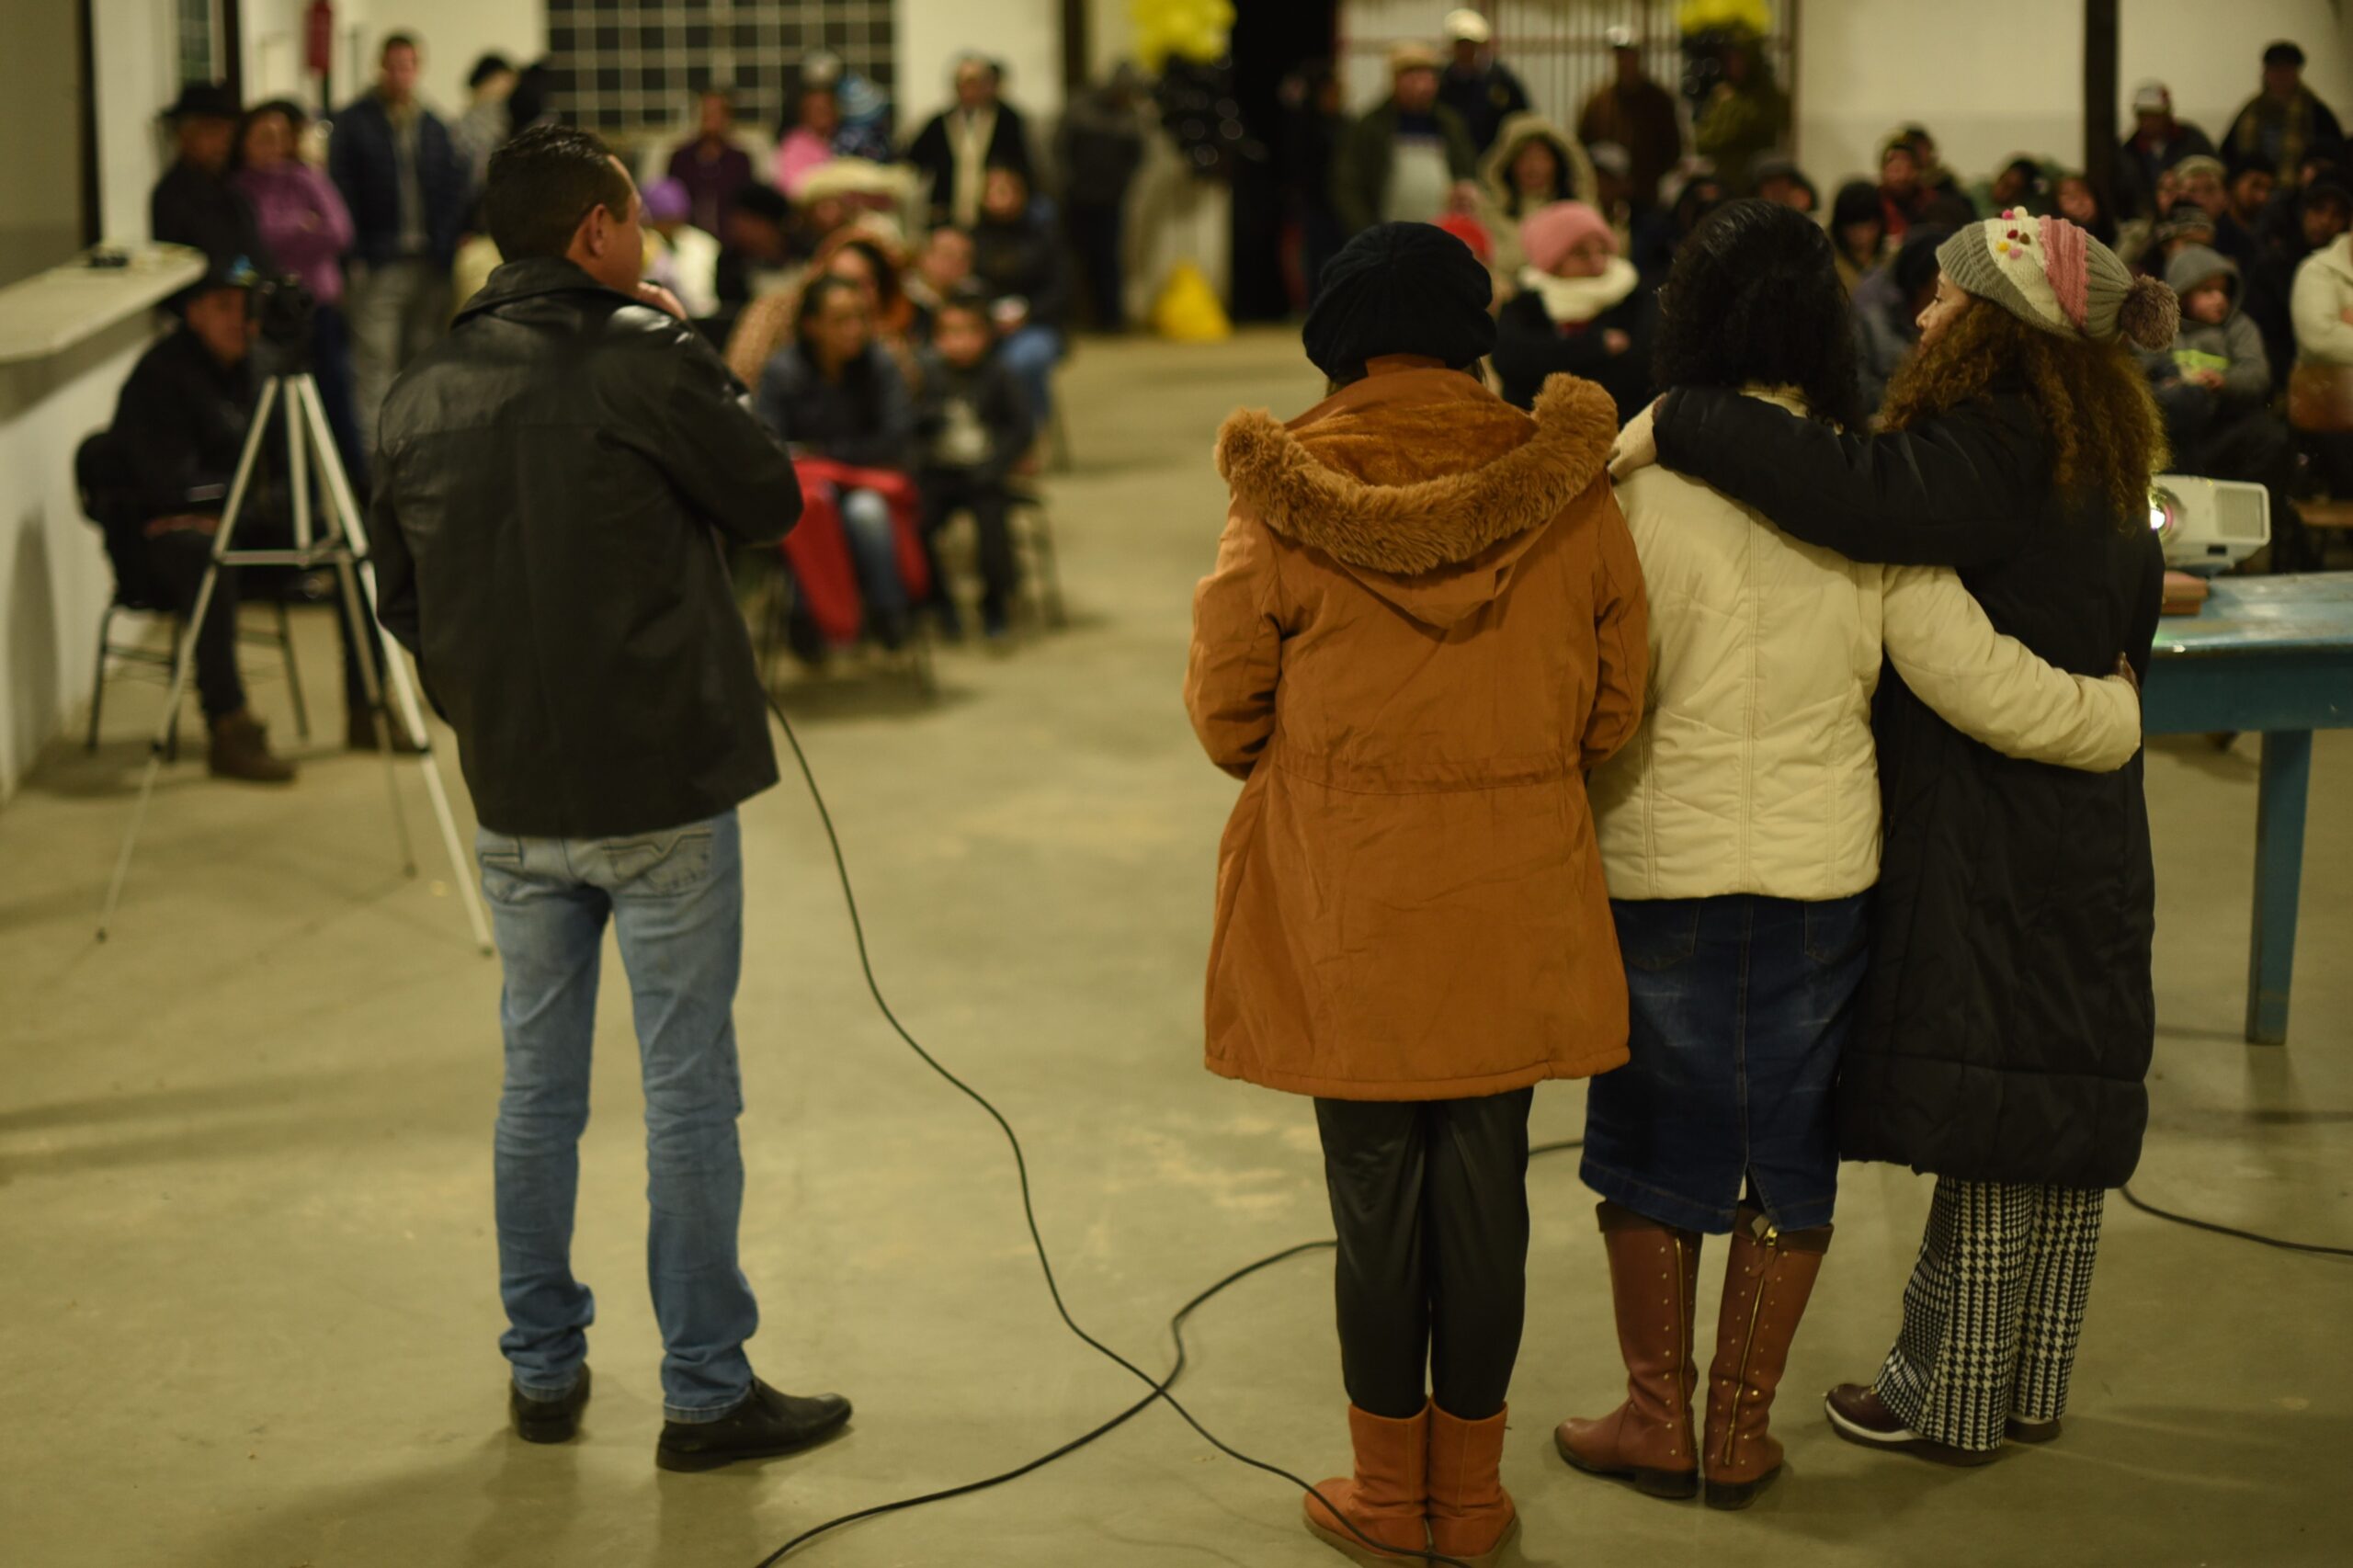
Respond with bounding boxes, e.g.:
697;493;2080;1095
1621;214;2174;1464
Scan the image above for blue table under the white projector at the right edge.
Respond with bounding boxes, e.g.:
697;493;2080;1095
2142;572;2353;1045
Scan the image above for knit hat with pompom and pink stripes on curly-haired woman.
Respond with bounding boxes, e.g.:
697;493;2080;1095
1937;207;2181;348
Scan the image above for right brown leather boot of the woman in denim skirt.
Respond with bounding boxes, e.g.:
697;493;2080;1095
1703;1208;1831;1509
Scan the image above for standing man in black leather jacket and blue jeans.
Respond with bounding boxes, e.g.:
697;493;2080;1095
369;125;849;1469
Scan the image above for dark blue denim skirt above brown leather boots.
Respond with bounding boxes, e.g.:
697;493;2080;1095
1581;892;1870;1236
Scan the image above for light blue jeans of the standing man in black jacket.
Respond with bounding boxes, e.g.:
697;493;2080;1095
475;812;760;1422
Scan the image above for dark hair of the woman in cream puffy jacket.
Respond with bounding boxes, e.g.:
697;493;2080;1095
1652;196;1861;426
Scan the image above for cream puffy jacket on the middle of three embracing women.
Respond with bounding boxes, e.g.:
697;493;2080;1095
1593;391;2142;900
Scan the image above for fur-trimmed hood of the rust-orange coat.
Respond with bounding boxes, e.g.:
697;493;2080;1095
1217;362;1617;626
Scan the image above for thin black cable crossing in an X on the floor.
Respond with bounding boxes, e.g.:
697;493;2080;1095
757;695;1584;1568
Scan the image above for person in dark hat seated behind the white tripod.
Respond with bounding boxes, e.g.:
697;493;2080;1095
92;264;412;784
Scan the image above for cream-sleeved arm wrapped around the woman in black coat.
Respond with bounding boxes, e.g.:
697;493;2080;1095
1885;567;2142;772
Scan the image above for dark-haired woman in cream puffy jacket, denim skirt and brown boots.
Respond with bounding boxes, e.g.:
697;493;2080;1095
1555;200;2142;1506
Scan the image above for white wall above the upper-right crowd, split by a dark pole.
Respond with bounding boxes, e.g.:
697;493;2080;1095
1798;0;2353;190
